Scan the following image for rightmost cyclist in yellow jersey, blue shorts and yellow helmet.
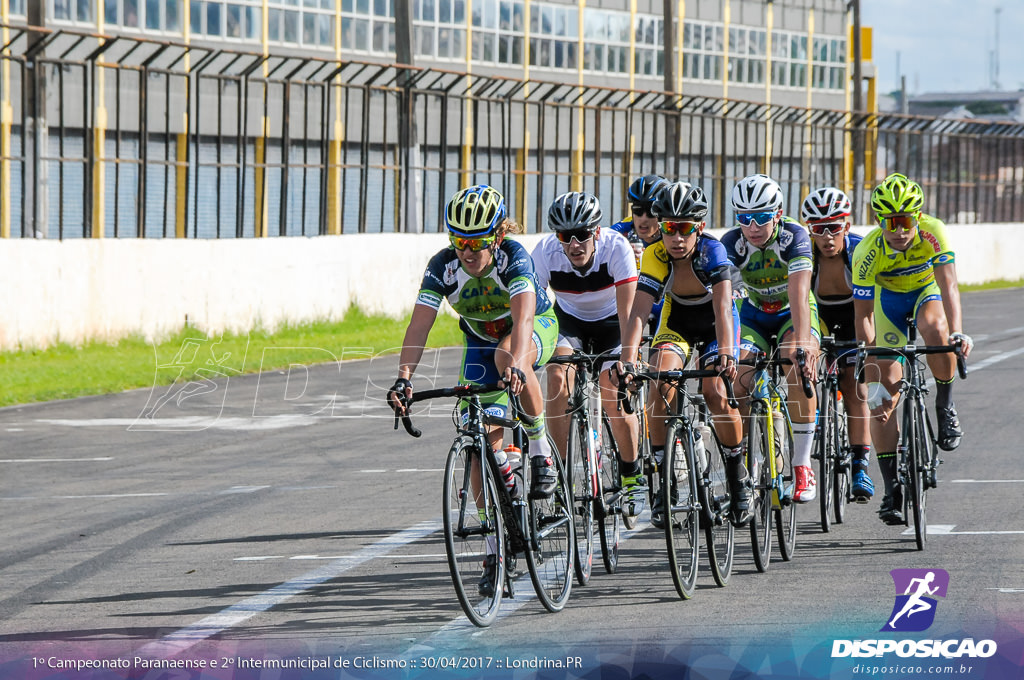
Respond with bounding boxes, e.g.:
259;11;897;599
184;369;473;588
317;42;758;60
853;173;974;524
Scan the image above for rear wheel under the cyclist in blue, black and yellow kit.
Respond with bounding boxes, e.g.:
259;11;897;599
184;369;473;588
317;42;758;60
699;430;736;588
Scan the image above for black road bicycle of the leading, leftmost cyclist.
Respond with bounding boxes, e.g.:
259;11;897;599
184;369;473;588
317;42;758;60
395;383;575;627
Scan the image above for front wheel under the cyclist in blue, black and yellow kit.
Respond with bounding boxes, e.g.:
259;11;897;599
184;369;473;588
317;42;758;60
662;418;700;600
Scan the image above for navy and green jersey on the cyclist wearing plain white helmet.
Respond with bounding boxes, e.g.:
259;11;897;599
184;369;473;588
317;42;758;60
722;216;813;314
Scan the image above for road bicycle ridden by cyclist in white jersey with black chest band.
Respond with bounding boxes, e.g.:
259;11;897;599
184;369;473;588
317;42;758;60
548;349;638;586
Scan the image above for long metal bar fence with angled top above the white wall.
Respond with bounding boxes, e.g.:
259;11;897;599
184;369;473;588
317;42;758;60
0;27;1024;239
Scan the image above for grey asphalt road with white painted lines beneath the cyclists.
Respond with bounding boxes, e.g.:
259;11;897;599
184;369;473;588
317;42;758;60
0;290;1024;668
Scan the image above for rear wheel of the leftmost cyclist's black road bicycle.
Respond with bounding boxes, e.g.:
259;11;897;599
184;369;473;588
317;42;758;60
526;444;575;612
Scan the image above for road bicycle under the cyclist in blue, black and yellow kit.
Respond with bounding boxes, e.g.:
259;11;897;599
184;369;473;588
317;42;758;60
618;370;736;600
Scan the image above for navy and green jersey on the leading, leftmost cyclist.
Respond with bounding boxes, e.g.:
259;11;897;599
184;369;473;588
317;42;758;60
416;239;551;342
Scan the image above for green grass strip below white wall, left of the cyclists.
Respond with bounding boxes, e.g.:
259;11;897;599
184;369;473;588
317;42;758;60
0;309;462;407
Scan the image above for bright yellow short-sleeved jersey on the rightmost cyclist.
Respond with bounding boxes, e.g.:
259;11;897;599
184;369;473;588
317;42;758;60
853;214;954;300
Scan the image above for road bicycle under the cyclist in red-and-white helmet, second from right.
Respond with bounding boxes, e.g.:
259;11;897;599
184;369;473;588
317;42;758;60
811;335;867;532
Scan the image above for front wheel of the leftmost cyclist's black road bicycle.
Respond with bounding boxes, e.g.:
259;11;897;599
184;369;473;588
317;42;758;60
441;437;507;627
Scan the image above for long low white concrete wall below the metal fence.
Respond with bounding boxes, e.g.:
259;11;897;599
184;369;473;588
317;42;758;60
0;224;1024;349
